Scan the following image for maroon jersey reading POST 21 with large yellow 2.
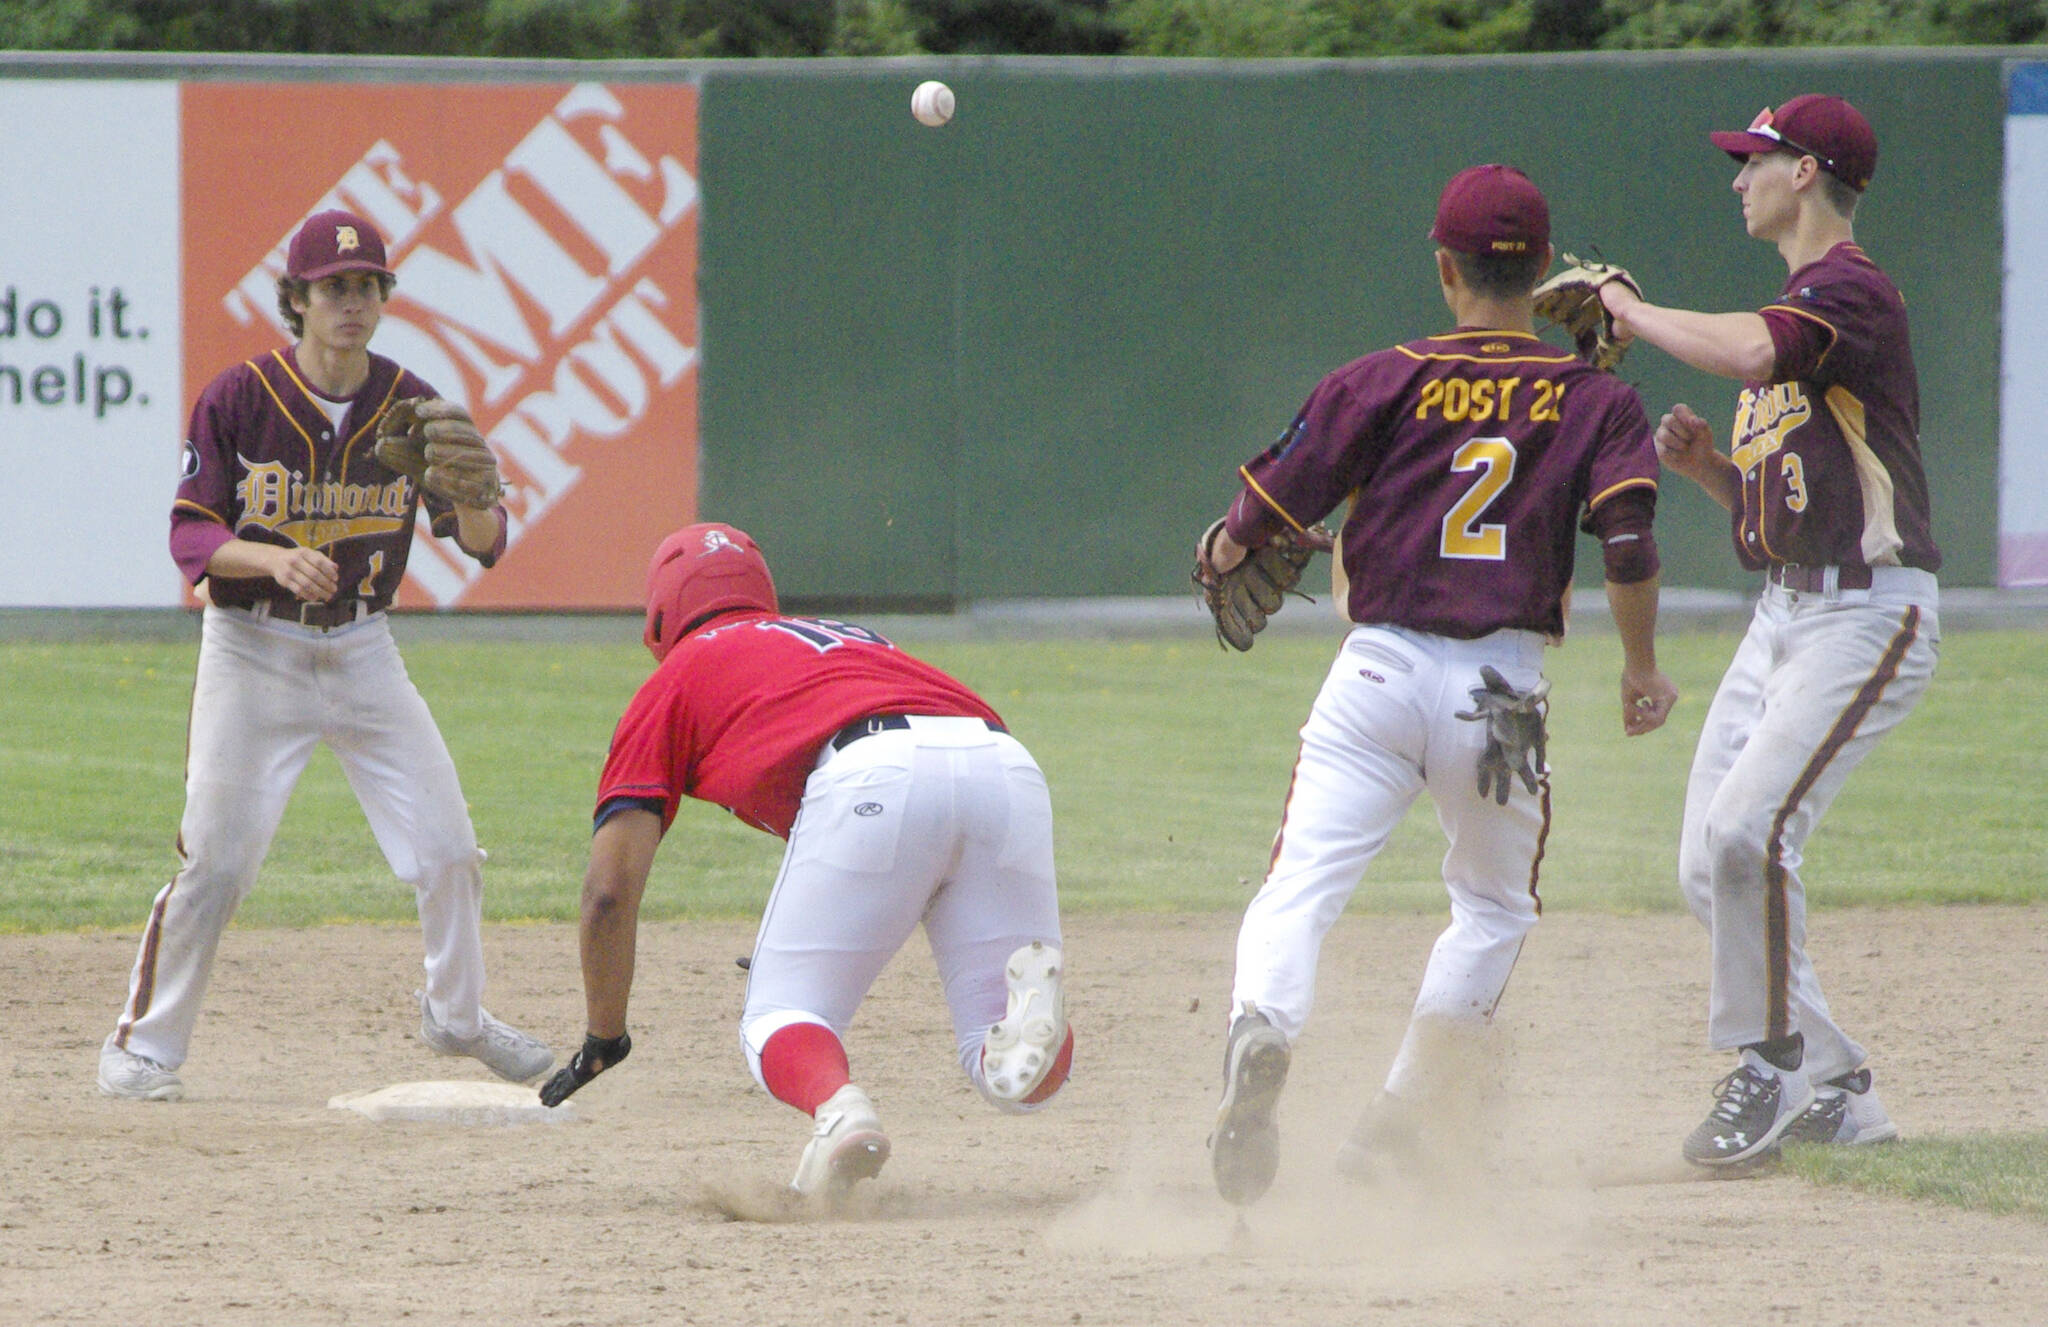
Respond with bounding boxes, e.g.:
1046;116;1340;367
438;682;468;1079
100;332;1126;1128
1229;330;1657;639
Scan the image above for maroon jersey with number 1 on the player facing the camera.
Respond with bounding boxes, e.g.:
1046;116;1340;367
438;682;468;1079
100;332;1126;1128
170;348;506;616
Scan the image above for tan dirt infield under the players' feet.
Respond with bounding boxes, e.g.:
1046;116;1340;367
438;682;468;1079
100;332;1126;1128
16;907;2048;1327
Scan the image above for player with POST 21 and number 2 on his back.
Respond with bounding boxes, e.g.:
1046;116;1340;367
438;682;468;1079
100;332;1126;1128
1202;166;1677;1204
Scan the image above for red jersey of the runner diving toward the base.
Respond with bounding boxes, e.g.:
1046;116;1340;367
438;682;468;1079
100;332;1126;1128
598;612;1001;838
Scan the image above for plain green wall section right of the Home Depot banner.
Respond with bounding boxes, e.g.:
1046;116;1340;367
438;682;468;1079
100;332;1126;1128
694;51;2005;606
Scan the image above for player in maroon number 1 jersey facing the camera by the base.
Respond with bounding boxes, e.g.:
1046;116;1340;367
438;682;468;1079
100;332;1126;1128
98;211;555;1100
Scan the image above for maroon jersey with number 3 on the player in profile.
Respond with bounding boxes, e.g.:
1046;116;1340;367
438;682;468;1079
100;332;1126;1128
1731;244;1942;571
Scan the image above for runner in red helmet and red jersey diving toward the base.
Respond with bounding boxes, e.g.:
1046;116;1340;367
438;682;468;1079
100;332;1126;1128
541;524;1073;1202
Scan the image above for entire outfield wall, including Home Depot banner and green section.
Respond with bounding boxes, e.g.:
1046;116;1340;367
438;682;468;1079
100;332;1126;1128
0;49;2048;606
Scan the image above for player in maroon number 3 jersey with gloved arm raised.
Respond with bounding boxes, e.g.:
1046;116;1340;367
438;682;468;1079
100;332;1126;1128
1599;96;1942;1165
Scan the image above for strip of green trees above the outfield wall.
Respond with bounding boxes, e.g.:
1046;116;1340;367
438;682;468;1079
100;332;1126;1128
0;0;2048;59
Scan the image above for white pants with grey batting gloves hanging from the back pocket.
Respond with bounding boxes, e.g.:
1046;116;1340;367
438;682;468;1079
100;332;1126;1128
1231;627;1550;1096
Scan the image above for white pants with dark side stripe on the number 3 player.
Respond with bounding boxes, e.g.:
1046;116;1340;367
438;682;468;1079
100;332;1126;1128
1677;567;1942;1081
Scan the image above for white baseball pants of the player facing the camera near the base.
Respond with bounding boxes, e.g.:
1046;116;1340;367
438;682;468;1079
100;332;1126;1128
115;606;483;1069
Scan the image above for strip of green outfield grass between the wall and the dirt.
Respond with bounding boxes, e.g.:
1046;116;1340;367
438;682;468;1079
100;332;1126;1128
0;623;2048;932
